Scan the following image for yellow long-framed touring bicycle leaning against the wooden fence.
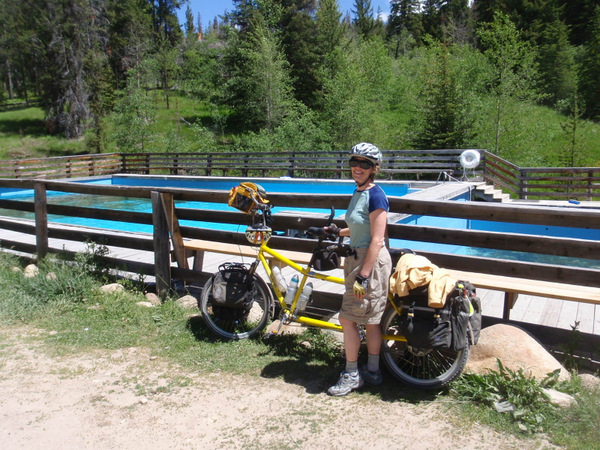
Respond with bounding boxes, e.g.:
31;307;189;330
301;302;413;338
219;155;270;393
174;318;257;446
198;185;469;389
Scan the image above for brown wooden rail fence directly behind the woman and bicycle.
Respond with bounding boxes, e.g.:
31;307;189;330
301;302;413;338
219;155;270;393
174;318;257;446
0;179;600;298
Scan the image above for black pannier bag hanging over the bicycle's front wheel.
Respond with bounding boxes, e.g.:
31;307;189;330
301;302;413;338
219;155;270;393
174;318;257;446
211;263;253;320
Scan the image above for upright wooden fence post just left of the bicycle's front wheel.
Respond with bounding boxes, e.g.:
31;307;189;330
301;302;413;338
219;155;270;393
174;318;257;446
150;191;171;300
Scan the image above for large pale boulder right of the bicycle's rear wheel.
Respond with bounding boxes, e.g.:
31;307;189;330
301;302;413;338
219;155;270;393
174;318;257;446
466;324;570;381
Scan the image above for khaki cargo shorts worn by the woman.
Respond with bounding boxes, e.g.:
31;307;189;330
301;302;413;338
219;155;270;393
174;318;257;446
340;247;392;325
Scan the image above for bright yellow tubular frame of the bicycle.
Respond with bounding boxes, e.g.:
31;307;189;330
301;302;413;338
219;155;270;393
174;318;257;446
250;242;406;342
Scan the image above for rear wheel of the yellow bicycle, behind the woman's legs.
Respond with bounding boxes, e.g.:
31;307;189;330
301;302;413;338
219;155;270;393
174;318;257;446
381;307;470;390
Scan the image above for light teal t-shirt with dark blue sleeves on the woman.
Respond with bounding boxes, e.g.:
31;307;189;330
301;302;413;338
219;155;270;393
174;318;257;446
346;185;390;248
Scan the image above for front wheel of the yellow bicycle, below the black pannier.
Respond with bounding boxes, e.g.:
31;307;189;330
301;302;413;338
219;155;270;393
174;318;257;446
198;275;273;340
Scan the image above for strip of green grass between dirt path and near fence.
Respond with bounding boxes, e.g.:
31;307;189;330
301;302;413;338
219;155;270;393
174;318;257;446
0;247;600;449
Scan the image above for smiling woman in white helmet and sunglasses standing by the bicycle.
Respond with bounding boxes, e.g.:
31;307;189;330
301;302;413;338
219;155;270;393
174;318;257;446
328;142;392;396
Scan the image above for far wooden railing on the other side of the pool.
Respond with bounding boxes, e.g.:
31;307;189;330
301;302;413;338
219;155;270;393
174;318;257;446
0;149;600;201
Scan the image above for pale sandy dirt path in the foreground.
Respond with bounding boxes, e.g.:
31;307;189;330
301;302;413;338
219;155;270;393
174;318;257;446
0;328;543;450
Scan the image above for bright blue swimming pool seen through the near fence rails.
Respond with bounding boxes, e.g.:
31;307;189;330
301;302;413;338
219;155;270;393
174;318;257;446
0;175;600;267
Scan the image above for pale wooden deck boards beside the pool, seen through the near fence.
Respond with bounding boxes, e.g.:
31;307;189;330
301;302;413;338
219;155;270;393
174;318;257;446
0;229;600;343
